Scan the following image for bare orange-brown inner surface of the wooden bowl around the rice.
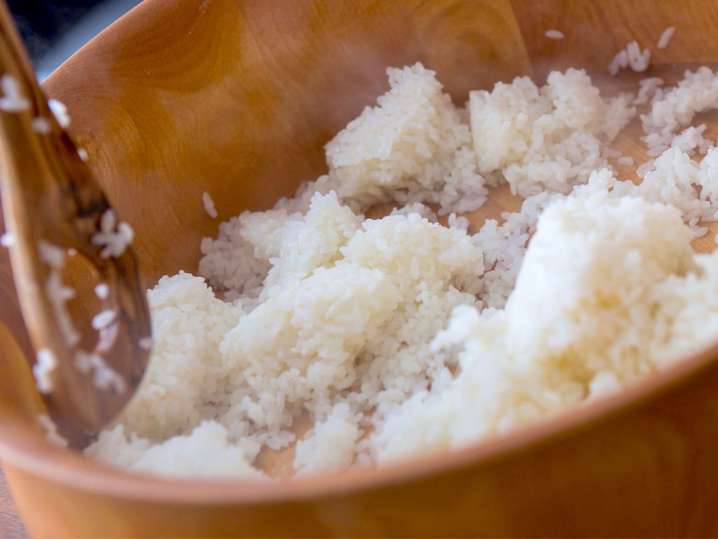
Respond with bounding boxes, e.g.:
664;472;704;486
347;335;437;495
0;0;718;490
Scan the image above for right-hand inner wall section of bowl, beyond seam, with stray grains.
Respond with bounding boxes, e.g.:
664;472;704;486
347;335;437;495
511;0;718;80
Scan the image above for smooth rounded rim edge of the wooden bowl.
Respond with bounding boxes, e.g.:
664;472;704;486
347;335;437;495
0;0;718;506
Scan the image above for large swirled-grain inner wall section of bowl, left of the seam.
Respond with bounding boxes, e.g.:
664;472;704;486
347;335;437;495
42;0;529;286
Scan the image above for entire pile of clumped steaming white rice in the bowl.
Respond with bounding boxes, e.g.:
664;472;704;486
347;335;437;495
86;64;718;479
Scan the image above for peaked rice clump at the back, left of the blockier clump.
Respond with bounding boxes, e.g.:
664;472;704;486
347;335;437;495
324;64;487;214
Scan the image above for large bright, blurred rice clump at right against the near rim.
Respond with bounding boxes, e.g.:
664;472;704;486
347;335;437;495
380;192;700;460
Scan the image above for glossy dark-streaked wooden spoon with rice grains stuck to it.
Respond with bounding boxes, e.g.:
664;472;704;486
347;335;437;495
0;1;151;445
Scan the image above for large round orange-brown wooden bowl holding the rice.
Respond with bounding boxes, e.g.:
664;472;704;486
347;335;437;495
0;0;718;537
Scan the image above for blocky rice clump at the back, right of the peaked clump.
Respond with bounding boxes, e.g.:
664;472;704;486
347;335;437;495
469;69;636;197
